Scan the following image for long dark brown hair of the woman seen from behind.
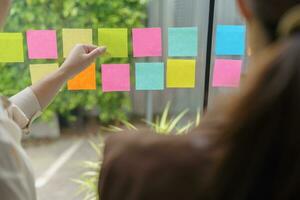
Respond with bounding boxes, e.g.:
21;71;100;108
200;0;300;200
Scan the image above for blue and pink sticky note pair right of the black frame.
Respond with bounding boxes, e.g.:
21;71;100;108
212;25;246;88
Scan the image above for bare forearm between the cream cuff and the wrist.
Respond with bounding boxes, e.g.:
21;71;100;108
31;68;68;109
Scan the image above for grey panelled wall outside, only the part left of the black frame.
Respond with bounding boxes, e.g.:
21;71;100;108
132;0;209;119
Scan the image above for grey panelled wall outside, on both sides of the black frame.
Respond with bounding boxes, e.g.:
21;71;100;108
132;0;243;117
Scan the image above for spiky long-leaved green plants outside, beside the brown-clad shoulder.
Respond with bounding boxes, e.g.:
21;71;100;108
74;103;200;200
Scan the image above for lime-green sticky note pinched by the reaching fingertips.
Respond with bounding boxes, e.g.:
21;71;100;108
98;28;128;58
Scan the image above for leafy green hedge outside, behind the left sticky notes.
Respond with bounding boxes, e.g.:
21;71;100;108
0;0;146;123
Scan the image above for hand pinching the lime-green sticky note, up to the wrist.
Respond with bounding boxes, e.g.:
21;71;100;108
60;44;106;79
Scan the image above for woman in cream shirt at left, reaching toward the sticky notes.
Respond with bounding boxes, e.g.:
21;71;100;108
0;0;105;200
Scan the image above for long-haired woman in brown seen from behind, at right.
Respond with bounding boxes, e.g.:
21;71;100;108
99;0;300;200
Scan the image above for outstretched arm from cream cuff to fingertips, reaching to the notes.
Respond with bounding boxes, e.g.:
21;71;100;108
10;45;106;120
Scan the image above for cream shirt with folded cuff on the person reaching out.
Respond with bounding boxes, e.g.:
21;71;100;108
0;88;41;200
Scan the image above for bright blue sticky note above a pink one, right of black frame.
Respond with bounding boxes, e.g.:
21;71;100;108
216;25;246;56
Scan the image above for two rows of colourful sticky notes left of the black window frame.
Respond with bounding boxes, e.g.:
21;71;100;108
0;27;209;92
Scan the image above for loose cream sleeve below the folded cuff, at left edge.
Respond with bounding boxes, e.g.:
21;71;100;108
0;104;36;200
